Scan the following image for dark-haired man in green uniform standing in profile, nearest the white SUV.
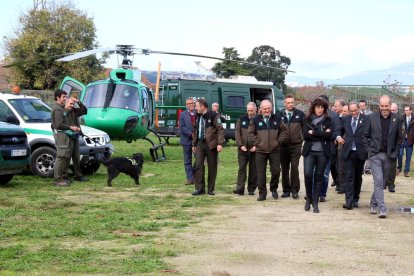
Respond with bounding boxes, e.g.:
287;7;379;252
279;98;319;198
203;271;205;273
52;89;80;186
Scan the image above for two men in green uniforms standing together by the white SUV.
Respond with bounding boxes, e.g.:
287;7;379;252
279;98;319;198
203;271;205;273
52;89;88;186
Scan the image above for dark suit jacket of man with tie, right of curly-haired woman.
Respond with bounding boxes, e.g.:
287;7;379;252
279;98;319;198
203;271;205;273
341;114;368;161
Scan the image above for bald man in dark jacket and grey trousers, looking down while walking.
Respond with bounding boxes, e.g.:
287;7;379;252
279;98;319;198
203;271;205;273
366;95;402;218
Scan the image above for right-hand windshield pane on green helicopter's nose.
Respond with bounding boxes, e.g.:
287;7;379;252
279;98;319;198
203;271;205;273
109;84;139;112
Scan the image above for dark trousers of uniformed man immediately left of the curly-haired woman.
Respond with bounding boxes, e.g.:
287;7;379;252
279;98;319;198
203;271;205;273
280;144;302;193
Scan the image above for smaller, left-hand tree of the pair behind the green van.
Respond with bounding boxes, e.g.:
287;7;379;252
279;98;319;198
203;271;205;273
211;47;249;78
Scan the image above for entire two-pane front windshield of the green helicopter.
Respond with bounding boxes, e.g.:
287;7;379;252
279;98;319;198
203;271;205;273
83;83;139;112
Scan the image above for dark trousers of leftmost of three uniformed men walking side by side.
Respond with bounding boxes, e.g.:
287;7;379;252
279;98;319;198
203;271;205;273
236;148;257;192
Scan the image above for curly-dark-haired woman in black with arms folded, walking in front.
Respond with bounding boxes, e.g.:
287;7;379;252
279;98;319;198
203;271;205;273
302;98;333;213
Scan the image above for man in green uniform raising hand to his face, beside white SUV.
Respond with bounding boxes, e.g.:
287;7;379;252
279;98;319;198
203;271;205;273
66;97;89;181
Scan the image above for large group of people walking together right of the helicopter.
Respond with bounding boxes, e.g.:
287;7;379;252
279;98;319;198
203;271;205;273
180;95;414;218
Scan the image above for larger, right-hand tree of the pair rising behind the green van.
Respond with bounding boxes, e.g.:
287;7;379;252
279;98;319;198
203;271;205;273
246;45;290;90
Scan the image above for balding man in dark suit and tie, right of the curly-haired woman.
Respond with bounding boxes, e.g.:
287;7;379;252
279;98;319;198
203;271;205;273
340;102;368;210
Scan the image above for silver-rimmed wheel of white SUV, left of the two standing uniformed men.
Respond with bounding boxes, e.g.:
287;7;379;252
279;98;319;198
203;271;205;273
30;147;56;177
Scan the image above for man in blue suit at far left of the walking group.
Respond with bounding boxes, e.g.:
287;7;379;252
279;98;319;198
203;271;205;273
179;98;196;185
